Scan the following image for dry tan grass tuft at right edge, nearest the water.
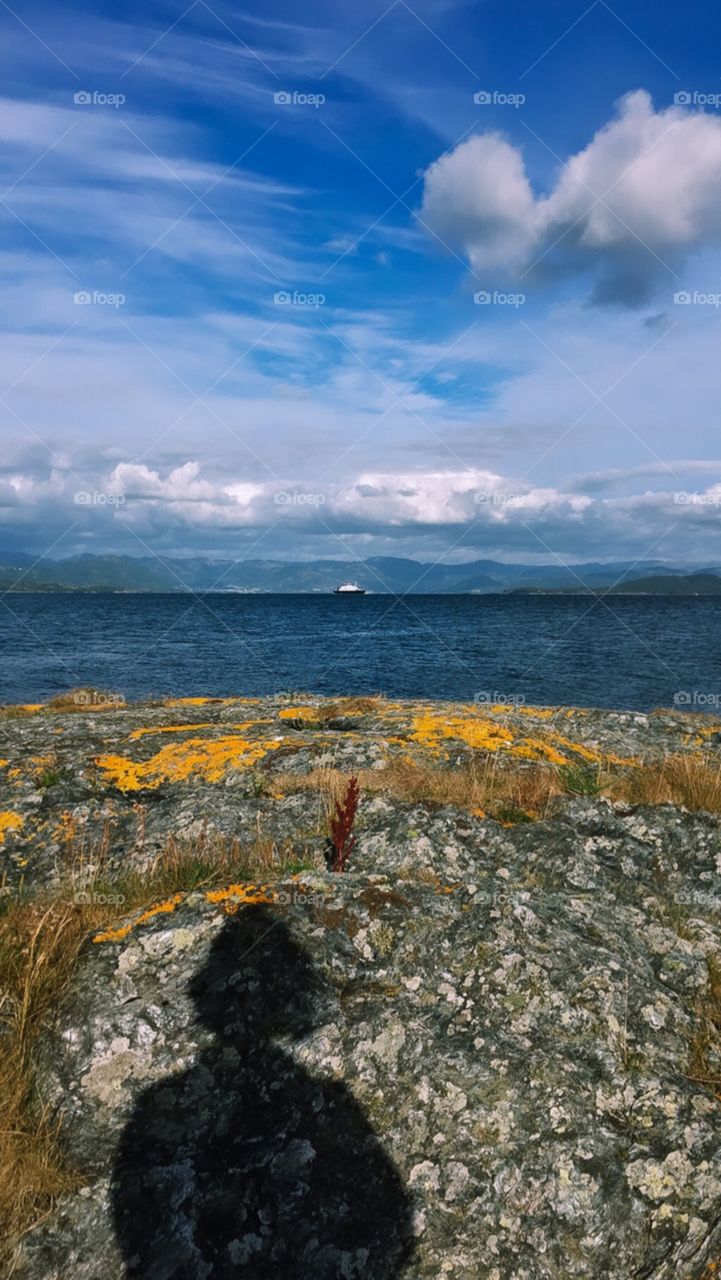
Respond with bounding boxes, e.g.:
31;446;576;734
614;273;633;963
604;755;721;813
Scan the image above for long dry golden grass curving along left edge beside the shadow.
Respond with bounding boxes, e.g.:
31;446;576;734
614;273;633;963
0;836;307;1265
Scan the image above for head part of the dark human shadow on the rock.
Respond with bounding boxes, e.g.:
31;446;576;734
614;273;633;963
188;906;328;1038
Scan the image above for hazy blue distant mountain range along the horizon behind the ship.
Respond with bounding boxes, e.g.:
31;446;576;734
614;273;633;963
0;553;721;595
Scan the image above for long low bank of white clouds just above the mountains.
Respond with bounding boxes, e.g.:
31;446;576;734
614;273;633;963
0;460;721;562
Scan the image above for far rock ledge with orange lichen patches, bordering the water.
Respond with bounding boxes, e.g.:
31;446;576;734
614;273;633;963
0;695;721;888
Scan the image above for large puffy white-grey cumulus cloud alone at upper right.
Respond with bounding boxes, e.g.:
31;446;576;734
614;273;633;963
423;90;721;305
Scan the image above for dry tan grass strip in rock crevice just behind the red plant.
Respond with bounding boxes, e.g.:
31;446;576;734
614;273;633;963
274;756;563;820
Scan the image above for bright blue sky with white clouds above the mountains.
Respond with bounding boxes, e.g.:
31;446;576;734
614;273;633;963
0;0;721;563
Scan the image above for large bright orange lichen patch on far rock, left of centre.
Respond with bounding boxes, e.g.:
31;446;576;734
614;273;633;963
95;722;279;791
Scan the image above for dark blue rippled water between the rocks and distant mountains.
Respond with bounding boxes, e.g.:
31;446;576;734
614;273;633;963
0;594;721;710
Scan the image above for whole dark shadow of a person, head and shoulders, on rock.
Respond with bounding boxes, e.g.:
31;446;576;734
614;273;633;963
111;906;414;1280
